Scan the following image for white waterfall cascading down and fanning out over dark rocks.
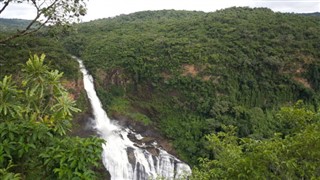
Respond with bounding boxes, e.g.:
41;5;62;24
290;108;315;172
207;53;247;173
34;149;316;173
76;58;191;180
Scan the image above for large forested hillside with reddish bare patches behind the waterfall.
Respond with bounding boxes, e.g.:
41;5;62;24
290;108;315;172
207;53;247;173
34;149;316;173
64;5;320;169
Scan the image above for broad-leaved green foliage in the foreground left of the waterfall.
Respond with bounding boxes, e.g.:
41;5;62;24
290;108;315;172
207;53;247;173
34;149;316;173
0;55;103;179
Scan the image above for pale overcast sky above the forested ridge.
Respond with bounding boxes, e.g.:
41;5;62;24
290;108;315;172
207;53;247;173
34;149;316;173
0;0;320;21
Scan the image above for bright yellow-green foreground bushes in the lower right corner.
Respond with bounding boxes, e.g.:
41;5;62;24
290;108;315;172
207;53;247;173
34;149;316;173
193;101;320;180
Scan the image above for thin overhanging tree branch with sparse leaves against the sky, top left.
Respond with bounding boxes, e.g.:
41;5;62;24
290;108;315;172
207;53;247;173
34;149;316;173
0;0;86;44
